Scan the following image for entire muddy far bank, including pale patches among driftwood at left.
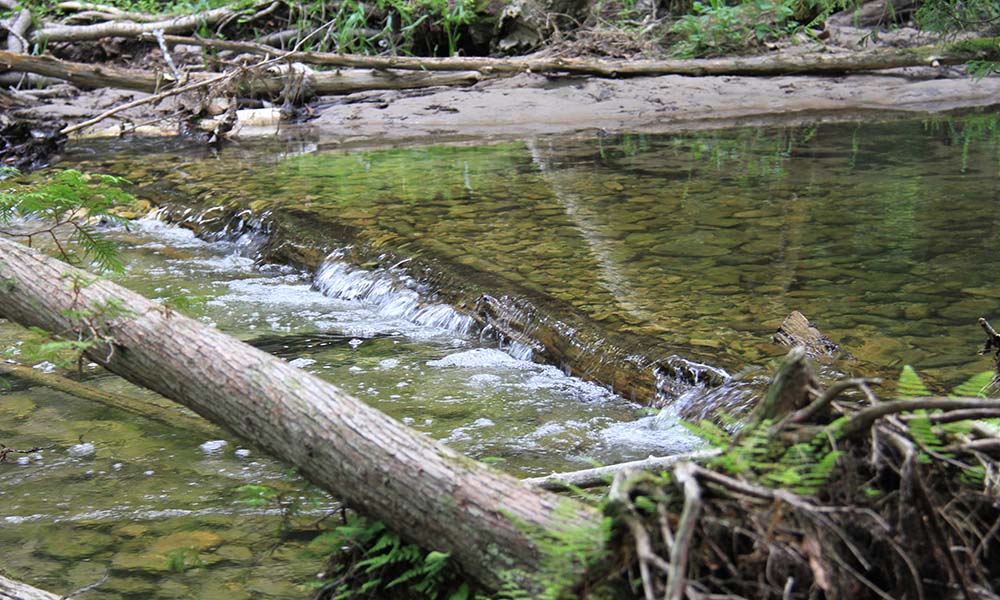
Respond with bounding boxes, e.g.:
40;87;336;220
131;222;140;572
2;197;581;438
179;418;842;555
11;67;1000;147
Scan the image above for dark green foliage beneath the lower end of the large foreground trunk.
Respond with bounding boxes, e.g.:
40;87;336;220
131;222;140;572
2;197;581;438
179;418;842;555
306;512;471;600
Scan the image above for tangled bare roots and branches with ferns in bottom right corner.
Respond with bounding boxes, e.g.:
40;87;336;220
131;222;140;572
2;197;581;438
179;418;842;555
609;351;1000;600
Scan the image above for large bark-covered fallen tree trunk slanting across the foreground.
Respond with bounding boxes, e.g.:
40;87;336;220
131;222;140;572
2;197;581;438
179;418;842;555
0;234;603;589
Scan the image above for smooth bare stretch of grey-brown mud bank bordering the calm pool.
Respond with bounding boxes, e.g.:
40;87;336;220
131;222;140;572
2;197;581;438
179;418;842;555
303;69;1000;141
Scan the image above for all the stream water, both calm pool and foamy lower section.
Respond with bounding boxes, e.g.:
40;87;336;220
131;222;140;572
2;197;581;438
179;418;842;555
0;114;1000;598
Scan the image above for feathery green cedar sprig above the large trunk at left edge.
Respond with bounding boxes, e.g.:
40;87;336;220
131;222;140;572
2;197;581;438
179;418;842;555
0;169;135;272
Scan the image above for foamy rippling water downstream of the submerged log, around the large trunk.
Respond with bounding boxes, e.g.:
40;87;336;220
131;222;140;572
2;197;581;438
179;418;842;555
0;222;697;598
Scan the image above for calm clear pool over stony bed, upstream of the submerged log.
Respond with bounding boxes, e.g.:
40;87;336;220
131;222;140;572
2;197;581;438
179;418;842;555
54;114;1000;392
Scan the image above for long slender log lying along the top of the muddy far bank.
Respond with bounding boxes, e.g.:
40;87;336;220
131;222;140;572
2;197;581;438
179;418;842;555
154;35;1000;77
